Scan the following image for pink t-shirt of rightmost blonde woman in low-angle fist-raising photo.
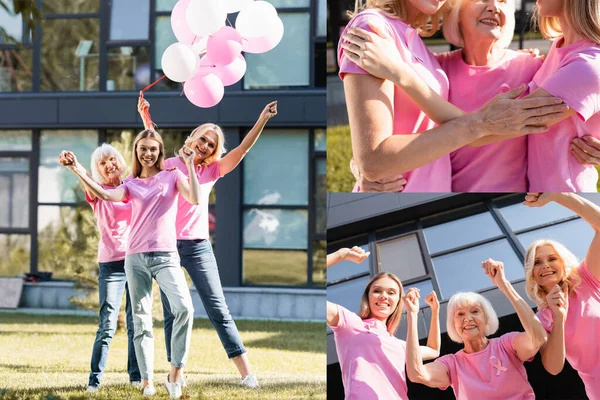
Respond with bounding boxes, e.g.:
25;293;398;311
537;261;600;400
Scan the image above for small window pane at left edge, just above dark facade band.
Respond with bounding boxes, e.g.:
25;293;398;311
0;48;33;93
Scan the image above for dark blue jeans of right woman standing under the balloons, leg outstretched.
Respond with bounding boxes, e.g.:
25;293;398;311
160;239;246;361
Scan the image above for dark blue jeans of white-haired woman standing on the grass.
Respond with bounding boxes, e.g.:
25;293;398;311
88;260;141;386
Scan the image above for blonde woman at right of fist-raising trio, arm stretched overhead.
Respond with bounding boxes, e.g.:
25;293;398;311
525;193;600;400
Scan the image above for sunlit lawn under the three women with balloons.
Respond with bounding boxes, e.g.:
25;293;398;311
0;313;326;400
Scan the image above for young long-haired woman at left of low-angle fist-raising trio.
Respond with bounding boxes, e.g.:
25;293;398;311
327;247;441;400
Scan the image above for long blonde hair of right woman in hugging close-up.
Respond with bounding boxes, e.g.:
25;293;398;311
532;0;600;45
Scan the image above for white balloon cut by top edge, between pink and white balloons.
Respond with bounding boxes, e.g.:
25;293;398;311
185;0;227;36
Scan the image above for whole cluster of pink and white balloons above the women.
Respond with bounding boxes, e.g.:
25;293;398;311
161;0;283;108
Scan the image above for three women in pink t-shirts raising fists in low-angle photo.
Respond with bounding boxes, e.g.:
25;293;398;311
327;193;600;400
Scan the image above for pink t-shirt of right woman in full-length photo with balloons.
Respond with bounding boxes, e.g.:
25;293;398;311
165;157;220;240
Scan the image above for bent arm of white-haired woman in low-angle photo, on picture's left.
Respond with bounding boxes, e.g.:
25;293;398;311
402;290;450;388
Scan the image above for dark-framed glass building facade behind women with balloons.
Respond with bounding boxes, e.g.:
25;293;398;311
0;0;326;320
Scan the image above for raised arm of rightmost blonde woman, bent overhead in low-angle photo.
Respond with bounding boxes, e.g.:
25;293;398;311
524;193;600;280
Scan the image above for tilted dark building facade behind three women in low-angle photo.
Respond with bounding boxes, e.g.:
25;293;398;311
327;193;600;399
